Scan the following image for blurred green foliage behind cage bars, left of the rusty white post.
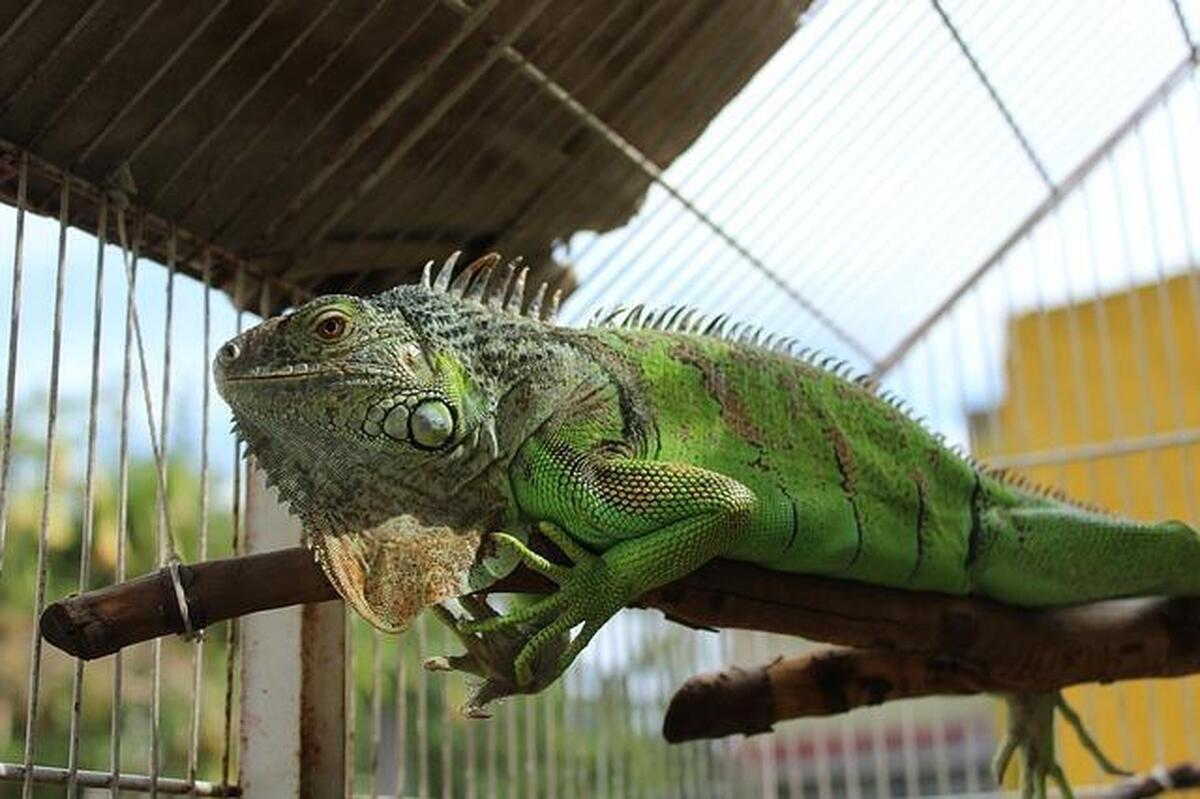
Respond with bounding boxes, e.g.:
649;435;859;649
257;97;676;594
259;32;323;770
0;395;236;795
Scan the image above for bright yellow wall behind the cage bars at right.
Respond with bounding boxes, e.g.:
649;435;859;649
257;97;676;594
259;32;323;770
972;271;1200;785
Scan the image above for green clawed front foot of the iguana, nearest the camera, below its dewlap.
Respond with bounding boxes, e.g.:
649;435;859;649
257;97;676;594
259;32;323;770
458;522;630;692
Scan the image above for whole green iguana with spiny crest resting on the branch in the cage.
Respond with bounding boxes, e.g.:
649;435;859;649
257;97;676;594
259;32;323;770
215;250;1200;794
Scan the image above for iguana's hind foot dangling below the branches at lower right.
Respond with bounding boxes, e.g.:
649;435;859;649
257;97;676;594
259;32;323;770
991;691;1129;799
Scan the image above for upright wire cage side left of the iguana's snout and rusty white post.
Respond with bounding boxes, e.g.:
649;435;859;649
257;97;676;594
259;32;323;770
0;156;250;795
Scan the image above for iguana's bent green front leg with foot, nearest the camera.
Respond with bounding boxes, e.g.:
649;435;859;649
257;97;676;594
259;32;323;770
461;439;757;685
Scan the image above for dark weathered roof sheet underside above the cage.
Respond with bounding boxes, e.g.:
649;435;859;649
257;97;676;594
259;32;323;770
0;0;808;310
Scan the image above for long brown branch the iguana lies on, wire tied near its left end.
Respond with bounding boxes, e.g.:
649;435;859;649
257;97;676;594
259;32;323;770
42;547;1200;710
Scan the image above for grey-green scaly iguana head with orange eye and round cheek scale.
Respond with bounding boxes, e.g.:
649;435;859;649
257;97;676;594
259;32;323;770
214;251;561;529
